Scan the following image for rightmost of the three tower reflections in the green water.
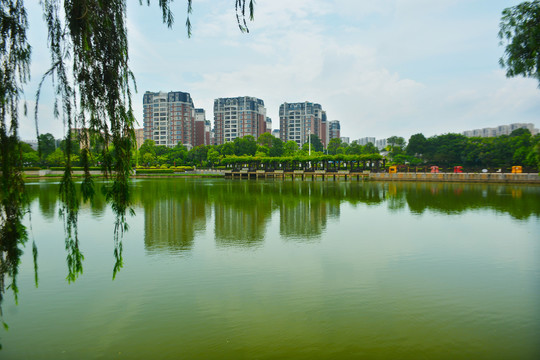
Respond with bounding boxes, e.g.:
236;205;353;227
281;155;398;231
279;197;332;240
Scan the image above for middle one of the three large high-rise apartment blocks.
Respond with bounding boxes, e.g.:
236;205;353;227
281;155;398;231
214;96;267;145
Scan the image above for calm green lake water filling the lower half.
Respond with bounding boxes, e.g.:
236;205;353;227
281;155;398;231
0;179;540;359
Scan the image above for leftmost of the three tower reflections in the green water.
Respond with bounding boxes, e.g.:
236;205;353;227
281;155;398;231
144;197;209;252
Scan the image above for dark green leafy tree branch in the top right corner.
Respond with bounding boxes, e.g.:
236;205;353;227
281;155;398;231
499;0;540;87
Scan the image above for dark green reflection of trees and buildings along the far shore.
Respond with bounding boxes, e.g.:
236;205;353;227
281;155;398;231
24;179;540;253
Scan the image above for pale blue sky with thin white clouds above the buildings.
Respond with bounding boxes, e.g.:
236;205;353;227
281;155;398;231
20;0;540;141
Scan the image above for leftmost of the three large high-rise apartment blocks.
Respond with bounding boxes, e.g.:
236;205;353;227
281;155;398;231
143;91;195;148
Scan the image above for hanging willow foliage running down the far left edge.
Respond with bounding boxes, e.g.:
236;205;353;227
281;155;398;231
0;0;30;348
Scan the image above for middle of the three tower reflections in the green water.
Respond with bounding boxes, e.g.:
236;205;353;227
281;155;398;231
214;202;272;246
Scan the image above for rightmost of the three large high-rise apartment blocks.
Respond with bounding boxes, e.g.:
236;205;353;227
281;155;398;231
279;101;327;147
